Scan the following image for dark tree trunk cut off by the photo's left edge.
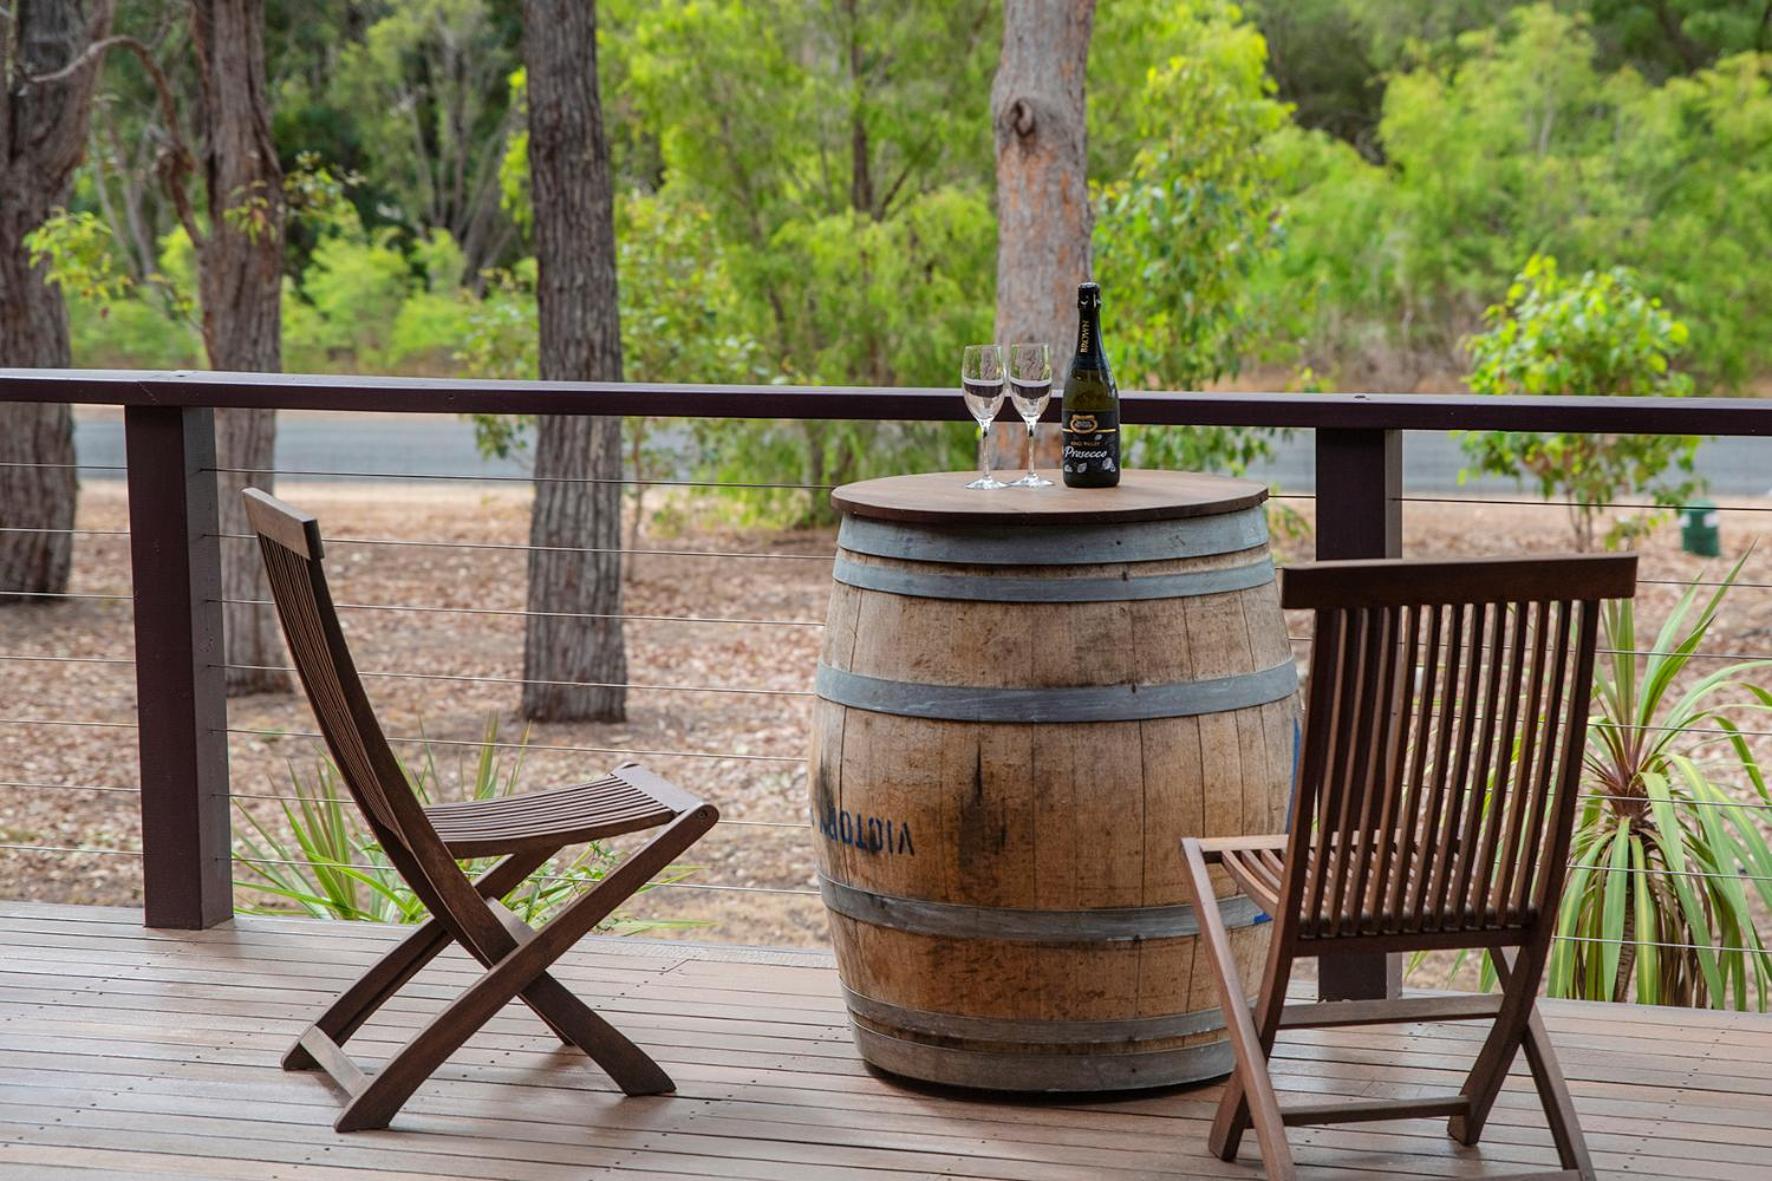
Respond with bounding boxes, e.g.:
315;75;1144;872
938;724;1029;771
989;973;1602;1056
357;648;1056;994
0;0;112;606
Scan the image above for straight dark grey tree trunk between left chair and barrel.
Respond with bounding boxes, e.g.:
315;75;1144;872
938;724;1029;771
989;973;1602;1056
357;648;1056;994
523;0;627;722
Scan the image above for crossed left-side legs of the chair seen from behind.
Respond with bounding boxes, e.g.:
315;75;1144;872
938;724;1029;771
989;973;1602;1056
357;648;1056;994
1182;839;1297;1181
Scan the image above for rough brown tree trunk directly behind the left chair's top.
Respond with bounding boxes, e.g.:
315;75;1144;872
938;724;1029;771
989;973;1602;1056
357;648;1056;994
191;0;291;695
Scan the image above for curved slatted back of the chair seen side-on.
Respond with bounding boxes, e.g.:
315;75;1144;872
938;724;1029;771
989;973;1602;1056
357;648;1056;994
245;488;496;938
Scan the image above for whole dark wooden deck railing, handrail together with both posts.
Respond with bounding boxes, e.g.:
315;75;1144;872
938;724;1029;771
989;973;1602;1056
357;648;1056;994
0;369;1772;997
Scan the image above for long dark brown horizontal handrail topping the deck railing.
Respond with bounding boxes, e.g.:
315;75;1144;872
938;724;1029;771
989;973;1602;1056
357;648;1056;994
0;369;1772;436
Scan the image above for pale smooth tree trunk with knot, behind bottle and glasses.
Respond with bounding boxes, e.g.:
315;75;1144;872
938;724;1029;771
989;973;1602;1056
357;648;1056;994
991;0;1095;466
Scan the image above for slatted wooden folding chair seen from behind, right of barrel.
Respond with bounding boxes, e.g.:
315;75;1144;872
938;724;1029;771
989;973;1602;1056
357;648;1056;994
1182;557;1636;1181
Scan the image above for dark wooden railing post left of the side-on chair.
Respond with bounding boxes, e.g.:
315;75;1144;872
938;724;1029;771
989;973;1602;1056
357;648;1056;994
124;406;234;929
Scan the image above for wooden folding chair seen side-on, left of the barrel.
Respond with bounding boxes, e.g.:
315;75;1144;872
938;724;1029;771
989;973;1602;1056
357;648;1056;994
246;488;719;1131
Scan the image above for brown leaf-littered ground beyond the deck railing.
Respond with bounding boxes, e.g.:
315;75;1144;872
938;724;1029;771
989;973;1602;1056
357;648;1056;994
0;482;1772;945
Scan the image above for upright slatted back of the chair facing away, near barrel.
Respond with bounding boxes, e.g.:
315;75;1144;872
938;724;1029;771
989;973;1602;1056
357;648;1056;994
1281;555;1636;942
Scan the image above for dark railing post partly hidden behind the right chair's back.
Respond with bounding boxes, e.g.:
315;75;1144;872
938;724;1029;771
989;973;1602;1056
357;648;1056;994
1317;429;1403;1000
